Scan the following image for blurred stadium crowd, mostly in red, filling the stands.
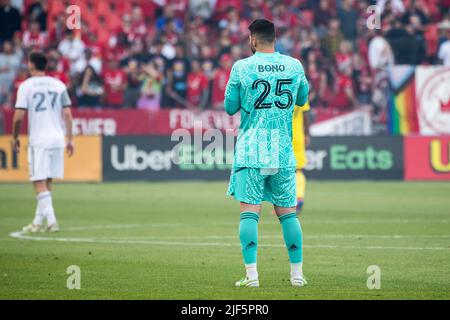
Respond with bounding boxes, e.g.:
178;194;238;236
0;0;450;119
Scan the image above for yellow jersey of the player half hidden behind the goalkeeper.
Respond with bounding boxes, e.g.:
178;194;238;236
292;102;310;169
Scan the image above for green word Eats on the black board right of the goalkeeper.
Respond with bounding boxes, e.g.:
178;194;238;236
330;144;394;170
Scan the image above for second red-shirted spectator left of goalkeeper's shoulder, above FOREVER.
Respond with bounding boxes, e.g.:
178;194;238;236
187;60;209;109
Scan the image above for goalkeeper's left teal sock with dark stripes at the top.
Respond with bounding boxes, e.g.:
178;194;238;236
239;212;259;265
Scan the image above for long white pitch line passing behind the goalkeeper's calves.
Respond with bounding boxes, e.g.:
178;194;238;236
9;231;450;250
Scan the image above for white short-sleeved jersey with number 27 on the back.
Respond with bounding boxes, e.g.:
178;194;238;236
16;76;71;149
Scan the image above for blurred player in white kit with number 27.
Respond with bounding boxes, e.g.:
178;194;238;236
12;52;74;233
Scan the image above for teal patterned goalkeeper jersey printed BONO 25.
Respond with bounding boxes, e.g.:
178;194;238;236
225;52;309;169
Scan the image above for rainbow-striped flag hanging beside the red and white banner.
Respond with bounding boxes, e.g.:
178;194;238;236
388;66;419;136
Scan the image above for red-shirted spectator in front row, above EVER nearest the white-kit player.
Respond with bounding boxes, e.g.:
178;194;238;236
102;57;127;108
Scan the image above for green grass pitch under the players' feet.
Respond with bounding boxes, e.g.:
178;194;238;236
0;182;450;299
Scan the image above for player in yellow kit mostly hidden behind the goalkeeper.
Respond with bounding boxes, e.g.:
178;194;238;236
292;102;310;213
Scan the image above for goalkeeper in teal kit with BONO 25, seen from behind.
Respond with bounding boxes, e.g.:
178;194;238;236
225;19;309;287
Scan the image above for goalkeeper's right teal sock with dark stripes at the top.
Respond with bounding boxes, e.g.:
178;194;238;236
278;212;303;263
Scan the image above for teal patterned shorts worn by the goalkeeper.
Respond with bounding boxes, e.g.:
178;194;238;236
227;167;297;208
